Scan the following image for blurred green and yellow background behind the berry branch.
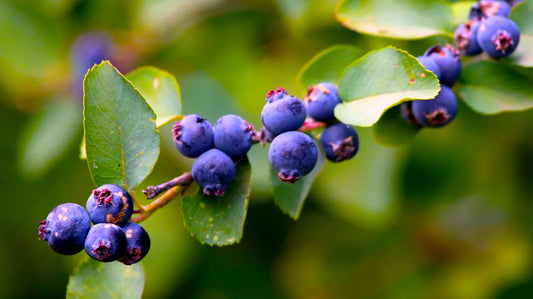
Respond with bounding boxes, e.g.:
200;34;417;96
0;0;533;298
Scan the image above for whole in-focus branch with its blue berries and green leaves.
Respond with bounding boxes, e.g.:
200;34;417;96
38;0;533;298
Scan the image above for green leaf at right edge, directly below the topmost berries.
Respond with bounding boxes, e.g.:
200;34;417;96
459;61;533;114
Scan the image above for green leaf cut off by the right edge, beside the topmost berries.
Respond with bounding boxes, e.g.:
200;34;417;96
509;1;533;67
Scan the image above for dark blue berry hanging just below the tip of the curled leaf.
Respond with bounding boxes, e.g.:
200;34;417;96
411;85;457;127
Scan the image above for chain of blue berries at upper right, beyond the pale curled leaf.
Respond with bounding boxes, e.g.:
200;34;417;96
401;0;520;128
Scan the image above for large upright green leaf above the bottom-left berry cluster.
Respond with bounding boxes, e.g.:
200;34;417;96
83;61;160;189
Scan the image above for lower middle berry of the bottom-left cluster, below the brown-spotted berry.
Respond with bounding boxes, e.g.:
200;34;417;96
85;223;127;262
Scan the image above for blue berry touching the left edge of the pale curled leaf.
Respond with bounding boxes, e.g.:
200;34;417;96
304;83;341;122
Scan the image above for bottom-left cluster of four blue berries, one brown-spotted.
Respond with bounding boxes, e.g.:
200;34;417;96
39;184;150;265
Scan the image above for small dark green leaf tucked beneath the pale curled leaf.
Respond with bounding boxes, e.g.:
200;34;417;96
372;106;420;147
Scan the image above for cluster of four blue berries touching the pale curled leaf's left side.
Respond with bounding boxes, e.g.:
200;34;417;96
261;82;359;183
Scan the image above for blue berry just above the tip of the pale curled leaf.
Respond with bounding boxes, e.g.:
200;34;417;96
424;45;462;86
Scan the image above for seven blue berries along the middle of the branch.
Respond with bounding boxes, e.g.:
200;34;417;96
172;83;359;196
